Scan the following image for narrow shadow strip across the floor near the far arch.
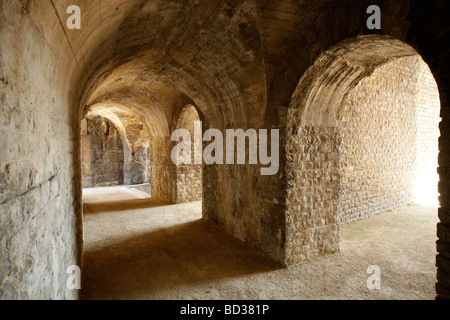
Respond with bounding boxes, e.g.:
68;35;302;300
83;198;173;214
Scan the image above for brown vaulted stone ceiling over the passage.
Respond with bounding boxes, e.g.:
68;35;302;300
17;0;414;132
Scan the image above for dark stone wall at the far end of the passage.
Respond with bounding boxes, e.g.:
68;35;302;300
81;118;124;188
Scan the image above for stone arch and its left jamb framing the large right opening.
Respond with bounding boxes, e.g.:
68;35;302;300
285;36;440;264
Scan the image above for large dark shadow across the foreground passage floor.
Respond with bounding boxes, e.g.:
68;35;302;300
81;220;282;300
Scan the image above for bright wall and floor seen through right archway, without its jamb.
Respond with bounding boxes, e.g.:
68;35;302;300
338;55;440;298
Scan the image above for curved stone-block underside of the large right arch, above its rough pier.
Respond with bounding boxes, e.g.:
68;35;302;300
289;35;417;127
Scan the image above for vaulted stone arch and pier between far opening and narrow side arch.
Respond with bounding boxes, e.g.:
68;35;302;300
80;87;213;203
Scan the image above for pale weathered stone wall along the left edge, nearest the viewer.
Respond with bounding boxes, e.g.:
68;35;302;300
0;1;82;300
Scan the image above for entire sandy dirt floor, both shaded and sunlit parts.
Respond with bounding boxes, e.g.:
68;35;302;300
82;187;438;300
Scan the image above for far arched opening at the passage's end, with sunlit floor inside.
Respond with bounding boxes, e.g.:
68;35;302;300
81;105;155;203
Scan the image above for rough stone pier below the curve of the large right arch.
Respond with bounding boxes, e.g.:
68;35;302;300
286;127;341;264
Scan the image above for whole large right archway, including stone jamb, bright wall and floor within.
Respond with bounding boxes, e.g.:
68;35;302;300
286;36;440;297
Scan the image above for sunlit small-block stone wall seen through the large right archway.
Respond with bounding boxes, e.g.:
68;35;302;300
338;56;439;224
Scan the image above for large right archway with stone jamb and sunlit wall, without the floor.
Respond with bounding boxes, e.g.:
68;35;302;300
286;36;439;264
